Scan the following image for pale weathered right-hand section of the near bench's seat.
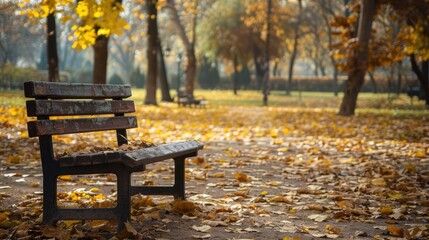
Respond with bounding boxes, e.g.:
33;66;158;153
118;140;204;167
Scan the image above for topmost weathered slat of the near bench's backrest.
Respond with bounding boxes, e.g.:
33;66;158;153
24;82;131;99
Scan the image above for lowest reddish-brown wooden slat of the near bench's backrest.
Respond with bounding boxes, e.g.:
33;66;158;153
27;116;137;137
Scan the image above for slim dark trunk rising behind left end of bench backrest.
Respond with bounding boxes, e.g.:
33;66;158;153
47;13;60;82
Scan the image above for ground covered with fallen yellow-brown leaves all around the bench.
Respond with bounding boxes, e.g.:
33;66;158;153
0;100;429;239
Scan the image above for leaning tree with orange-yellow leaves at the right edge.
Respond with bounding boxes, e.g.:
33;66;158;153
333;0;429;116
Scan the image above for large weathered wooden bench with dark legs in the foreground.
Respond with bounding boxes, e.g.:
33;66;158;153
24;82;203;231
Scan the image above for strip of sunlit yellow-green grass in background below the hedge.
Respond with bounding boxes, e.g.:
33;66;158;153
0;89;429;117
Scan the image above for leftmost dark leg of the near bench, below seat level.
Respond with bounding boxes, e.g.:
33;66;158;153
43;171;57;225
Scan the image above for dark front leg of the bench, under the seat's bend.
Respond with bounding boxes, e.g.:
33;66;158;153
116;169;131;232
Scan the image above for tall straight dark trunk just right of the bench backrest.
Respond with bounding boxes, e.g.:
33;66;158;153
144;0;158;105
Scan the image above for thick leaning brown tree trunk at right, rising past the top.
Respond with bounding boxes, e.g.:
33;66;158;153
338;0;376;116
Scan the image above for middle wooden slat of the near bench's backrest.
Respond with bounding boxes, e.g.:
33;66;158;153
27;100;135;117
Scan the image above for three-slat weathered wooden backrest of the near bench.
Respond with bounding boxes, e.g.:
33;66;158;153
24;82;137;145
